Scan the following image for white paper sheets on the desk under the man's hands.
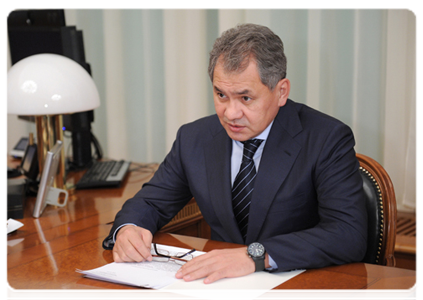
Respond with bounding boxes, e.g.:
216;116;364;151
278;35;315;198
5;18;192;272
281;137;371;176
77;244;304;300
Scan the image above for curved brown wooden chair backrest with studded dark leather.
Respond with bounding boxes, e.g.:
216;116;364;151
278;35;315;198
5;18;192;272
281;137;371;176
357;154;397;267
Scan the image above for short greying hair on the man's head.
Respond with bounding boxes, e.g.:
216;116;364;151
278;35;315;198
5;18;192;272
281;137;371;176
208;24;286;90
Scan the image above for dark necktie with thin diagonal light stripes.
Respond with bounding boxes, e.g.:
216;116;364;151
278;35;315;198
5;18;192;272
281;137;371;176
232;139;263;241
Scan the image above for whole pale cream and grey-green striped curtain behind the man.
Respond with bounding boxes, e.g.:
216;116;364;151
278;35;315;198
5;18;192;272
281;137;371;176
6;8;420;212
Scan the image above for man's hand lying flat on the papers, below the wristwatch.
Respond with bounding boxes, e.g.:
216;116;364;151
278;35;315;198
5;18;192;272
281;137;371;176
176;247;255;283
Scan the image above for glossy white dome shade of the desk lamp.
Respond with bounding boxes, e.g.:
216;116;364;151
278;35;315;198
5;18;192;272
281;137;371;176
5;54;100;115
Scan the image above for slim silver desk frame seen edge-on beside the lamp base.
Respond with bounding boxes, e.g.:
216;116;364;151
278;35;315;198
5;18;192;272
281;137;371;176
32;141;69;218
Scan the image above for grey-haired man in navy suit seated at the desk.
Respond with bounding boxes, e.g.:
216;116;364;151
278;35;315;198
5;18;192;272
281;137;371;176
103;24;367;283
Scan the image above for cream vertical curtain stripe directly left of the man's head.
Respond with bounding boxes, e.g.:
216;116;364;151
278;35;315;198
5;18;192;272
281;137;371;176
164;9;209;149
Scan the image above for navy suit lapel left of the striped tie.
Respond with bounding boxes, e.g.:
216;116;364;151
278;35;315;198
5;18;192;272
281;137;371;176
205;127;243;244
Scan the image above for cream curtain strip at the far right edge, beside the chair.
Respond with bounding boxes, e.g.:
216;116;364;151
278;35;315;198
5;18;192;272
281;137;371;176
382;9;420;209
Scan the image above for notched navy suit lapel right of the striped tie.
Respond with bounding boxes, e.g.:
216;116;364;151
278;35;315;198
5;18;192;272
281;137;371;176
246;102;302;244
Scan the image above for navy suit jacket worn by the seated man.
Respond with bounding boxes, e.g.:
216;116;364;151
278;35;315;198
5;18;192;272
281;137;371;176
103;100;367;271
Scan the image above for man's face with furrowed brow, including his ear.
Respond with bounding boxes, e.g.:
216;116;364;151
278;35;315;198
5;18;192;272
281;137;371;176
213;59;289;141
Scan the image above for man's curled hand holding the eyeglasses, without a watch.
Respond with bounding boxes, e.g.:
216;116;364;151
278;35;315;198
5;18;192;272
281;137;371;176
113;225;153;262
